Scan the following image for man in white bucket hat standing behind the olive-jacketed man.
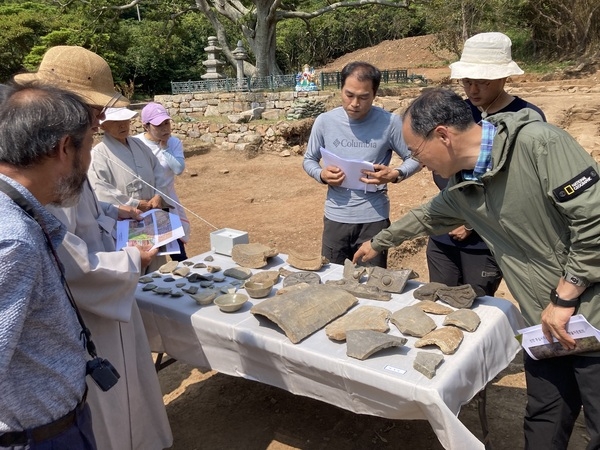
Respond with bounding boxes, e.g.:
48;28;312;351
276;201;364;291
424;32;546;296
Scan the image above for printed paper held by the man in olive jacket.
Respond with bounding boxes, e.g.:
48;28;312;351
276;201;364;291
517;314;600;359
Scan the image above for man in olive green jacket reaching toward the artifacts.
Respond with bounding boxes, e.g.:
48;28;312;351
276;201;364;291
354;89;600;449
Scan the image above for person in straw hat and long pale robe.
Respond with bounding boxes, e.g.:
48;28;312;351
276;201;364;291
15;46;172;450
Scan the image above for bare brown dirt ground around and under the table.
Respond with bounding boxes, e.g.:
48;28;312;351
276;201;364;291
159;38;600;450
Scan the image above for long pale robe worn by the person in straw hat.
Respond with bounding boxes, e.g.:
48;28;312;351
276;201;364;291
48;182;173;450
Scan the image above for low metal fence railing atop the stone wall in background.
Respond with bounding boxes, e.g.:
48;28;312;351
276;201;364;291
171;69;427;94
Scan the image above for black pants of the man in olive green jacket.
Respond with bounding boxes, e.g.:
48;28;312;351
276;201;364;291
524;354;600;450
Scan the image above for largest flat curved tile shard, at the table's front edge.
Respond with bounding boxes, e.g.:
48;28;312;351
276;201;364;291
250;285;358;344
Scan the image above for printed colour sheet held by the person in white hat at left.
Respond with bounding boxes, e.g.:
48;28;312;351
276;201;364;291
116;209;185;255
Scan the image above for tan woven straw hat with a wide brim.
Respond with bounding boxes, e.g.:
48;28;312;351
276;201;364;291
14;45;129;107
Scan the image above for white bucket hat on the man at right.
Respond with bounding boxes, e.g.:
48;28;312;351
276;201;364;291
450;32;525;80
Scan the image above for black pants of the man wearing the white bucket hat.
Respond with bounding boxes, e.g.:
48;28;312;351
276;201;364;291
427;239;502;296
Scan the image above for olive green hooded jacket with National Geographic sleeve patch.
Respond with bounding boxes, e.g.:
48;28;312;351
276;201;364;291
372;109;600;328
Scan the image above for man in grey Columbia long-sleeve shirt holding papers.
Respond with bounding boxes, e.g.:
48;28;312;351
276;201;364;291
303;62;420;268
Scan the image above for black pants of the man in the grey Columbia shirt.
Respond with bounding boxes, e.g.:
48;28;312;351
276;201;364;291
321;217;390;269
